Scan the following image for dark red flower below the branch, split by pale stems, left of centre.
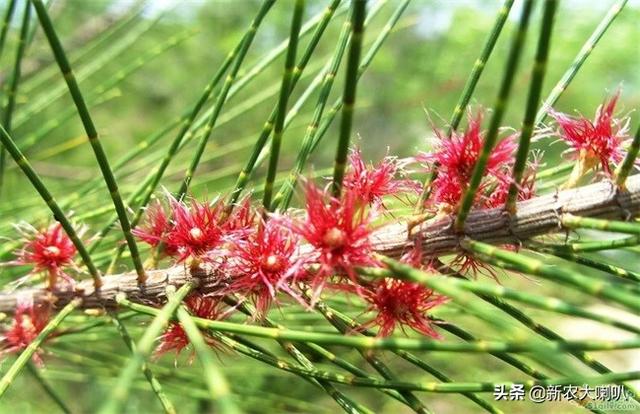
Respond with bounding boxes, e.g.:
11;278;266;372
154;294;226;358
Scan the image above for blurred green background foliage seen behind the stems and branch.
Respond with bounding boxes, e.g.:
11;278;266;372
0;0;640;413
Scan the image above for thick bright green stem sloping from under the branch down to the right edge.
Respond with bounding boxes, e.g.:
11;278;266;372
461;240;640;311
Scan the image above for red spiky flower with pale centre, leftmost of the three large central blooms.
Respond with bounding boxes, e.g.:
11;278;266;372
166;198;224;262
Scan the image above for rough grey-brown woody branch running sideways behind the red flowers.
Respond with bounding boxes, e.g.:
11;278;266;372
0;174;640;312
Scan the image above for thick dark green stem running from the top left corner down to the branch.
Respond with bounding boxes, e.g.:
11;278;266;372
32;0;146;283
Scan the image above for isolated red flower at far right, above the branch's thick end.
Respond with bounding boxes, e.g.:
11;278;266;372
550;92;629;175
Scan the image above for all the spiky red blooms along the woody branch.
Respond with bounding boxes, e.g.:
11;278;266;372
2;96;628;362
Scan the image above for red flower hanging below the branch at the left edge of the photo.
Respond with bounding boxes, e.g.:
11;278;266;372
0;299;51;364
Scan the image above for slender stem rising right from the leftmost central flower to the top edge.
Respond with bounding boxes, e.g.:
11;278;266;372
176;0;275;200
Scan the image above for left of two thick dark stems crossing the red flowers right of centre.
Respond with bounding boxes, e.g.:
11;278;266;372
454;0;533;232
